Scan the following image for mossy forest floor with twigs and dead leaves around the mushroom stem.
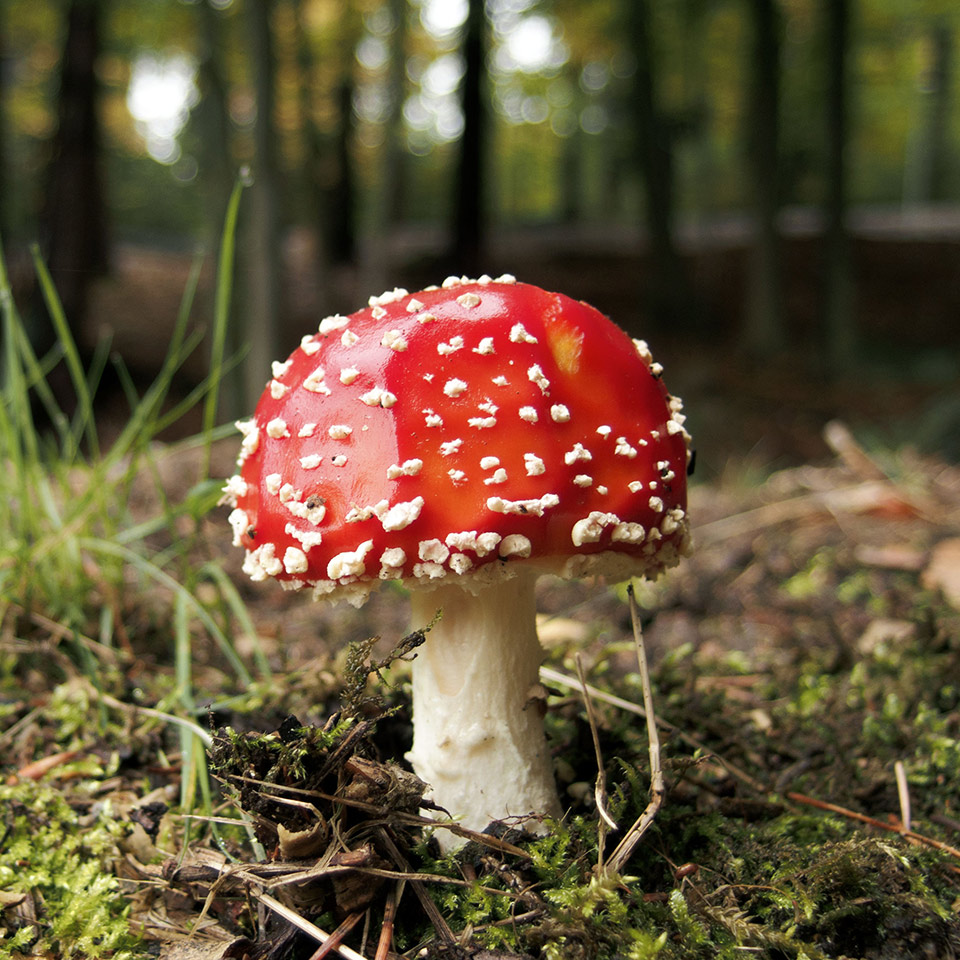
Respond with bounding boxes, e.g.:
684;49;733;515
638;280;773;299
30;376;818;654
0;234;960;960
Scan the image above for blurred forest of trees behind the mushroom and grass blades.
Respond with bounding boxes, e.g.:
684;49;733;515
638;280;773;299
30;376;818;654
0;0;960;469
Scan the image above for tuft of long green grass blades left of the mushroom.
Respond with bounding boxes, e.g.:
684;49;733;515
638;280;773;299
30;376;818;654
0;189;269;706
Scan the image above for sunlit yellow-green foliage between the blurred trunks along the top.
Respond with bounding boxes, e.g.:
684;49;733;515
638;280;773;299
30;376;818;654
3;0;960;231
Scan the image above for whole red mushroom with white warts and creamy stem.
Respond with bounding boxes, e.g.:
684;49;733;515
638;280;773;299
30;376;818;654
225;276;689;846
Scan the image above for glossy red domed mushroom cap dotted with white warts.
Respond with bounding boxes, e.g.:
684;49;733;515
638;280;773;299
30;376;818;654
225;277;689;595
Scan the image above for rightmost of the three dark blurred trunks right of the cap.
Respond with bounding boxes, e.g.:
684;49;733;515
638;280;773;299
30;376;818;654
823;0;858;374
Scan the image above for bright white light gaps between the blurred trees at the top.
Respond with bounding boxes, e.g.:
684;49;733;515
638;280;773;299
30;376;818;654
110;0;600;213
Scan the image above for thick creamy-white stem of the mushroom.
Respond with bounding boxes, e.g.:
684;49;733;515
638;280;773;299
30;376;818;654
407;570;561;850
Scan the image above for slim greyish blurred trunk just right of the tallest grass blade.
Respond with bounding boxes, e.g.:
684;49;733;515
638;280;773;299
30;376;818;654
242;0;283;410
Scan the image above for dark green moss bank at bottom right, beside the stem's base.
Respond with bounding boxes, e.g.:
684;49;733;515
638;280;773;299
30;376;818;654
406;700;960;960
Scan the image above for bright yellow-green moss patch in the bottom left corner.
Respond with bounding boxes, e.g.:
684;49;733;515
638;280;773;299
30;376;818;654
0;783;146;960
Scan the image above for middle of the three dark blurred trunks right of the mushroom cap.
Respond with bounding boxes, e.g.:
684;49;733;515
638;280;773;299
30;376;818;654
744;0;786;357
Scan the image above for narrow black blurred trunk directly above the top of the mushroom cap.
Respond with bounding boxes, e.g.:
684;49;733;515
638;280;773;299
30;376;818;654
453;0;489;276
